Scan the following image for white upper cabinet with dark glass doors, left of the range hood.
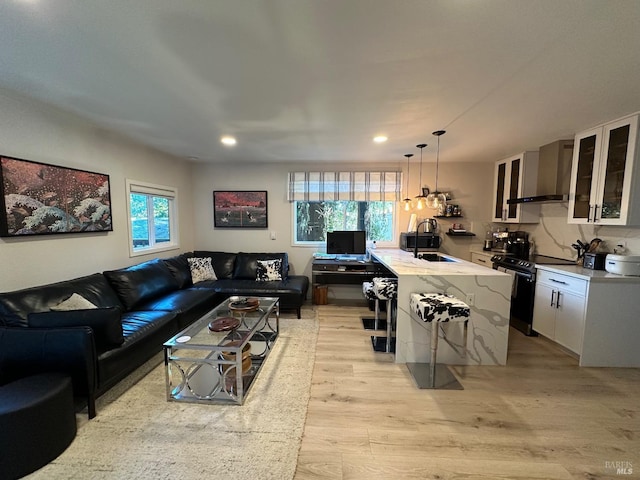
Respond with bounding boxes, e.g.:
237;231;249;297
492;152;540;223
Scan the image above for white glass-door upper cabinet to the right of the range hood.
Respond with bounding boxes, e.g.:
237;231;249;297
568;115;640;225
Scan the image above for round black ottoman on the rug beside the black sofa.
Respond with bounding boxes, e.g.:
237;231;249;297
0;373;76;479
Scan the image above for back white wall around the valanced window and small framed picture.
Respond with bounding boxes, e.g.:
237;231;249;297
193;162;493;286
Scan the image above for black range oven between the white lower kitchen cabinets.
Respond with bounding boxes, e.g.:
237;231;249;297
491;254;575;336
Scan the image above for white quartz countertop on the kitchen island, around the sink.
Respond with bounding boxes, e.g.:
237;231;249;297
371;248;507;277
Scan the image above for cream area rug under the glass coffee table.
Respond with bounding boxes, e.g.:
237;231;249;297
27;309;318;480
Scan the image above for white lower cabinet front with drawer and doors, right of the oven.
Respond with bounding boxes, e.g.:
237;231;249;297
533;270;587;355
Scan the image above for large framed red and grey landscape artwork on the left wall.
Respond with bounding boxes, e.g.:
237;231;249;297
0;156;113;237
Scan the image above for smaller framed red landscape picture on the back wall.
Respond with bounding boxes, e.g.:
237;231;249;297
213;190;268;228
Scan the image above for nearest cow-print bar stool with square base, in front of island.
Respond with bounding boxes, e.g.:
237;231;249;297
407;293;471;390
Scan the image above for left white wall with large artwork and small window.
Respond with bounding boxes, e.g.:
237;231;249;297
0;90;194;291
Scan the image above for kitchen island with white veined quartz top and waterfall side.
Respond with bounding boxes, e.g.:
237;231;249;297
371;249;512;365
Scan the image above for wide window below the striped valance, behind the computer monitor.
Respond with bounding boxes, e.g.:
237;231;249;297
293;201;395;245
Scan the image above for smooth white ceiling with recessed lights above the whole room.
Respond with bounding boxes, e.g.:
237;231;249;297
0;0;640;164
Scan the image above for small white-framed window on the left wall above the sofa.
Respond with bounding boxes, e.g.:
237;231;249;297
127;180;179;256
